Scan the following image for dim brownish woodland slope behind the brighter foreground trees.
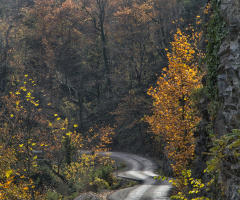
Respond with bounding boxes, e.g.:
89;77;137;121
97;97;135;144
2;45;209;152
1;0;205;155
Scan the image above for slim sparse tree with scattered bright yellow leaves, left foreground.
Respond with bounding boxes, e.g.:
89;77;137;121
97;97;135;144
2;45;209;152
0;74;62;200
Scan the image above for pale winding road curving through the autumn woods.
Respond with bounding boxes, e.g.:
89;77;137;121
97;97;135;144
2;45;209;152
107;152;172;200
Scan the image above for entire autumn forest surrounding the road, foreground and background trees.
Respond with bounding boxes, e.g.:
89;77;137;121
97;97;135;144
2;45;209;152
0;0;240;200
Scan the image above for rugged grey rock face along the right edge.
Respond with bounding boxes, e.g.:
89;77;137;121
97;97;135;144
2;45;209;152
217;0;240;200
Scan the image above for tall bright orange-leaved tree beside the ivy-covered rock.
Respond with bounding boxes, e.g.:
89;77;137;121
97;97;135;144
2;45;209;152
146;29;202;174
